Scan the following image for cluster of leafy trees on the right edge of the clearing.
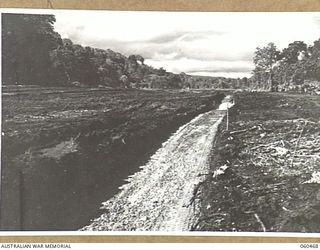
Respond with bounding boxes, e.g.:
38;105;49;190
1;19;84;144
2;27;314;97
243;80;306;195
252;39;320;92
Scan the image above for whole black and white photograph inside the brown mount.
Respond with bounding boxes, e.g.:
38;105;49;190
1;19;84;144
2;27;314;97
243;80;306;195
0;9;320;232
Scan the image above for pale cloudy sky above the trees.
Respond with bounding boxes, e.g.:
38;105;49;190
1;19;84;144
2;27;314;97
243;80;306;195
54;11;320;77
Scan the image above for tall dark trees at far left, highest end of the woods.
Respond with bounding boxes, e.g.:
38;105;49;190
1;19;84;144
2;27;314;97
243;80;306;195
2;14;61;85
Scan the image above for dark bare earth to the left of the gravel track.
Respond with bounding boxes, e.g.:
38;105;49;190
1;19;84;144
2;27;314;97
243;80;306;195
1;86;224;230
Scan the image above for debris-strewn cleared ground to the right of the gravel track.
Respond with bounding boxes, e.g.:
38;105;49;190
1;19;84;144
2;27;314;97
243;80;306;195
193;92;320;233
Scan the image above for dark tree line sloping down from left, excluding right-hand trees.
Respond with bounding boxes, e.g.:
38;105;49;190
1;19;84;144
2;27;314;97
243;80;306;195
2;14;246;88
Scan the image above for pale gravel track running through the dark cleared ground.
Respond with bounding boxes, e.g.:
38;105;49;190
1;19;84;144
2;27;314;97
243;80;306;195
81;97;234;232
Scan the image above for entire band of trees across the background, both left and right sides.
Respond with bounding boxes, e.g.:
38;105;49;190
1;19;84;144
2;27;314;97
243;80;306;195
2;13;320;92
